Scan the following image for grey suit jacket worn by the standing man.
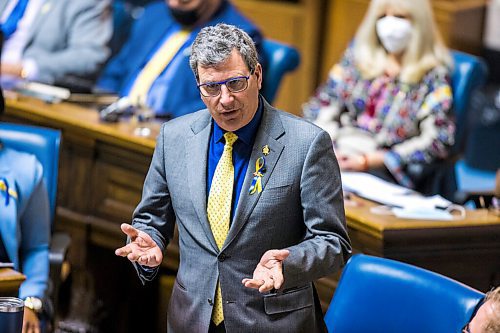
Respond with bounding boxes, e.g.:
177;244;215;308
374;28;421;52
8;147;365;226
133;103;351;332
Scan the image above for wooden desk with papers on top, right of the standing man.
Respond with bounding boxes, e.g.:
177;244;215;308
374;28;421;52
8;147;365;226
318;198;500;309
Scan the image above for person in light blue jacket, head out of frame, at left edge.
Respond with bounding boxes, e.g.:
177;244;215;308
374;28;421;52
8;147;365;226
0;138;50;333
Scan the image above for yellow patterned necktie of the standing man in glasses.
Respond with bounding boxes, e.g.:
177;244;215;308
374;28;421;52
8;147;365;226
207;132;238;325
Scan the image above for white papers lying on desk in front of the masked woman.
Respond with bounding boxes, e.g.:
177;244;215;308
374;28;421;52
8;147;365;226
342;172;451;209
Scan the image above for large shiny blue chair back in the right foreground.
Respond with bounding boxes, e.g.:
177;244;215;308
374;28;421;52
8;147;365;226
325;254;484;333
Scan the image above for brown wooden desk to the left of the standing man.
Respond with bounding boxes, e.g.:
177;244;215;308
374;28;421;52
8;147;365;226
2;94;171;333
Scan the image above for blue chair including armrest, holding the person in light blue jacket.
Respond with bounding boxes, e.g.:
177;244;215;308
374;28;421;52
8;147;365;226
0;122;70;322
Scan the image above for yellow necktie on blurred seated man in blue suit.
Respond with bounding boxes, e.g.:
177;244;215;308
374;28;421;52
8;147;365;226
128;30;190;106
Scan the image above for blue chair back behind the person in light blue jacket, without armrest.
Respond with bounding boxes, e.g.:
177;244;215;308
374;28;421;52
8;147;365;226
0;122;61;221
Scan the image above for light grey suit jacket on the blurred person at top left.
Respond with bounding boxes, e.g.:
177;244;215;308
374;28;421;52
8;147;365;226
0;0;113;84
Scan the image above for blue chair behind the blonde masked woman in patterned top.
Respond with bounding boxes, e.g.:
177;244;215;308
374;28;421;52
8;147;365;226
452;51;495;203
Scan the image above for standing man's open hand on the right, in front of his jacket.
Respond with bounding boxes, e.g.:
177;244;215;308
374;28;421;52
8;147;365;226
241;250;290;293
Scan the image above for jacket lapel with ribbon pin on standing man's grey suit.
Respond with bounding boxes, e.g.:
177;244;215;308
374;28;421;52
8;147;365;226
222;99;285;250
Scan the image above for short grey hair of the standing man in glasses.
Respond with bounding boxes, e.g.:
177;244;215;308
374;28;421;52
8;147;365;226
189;23;259;82
